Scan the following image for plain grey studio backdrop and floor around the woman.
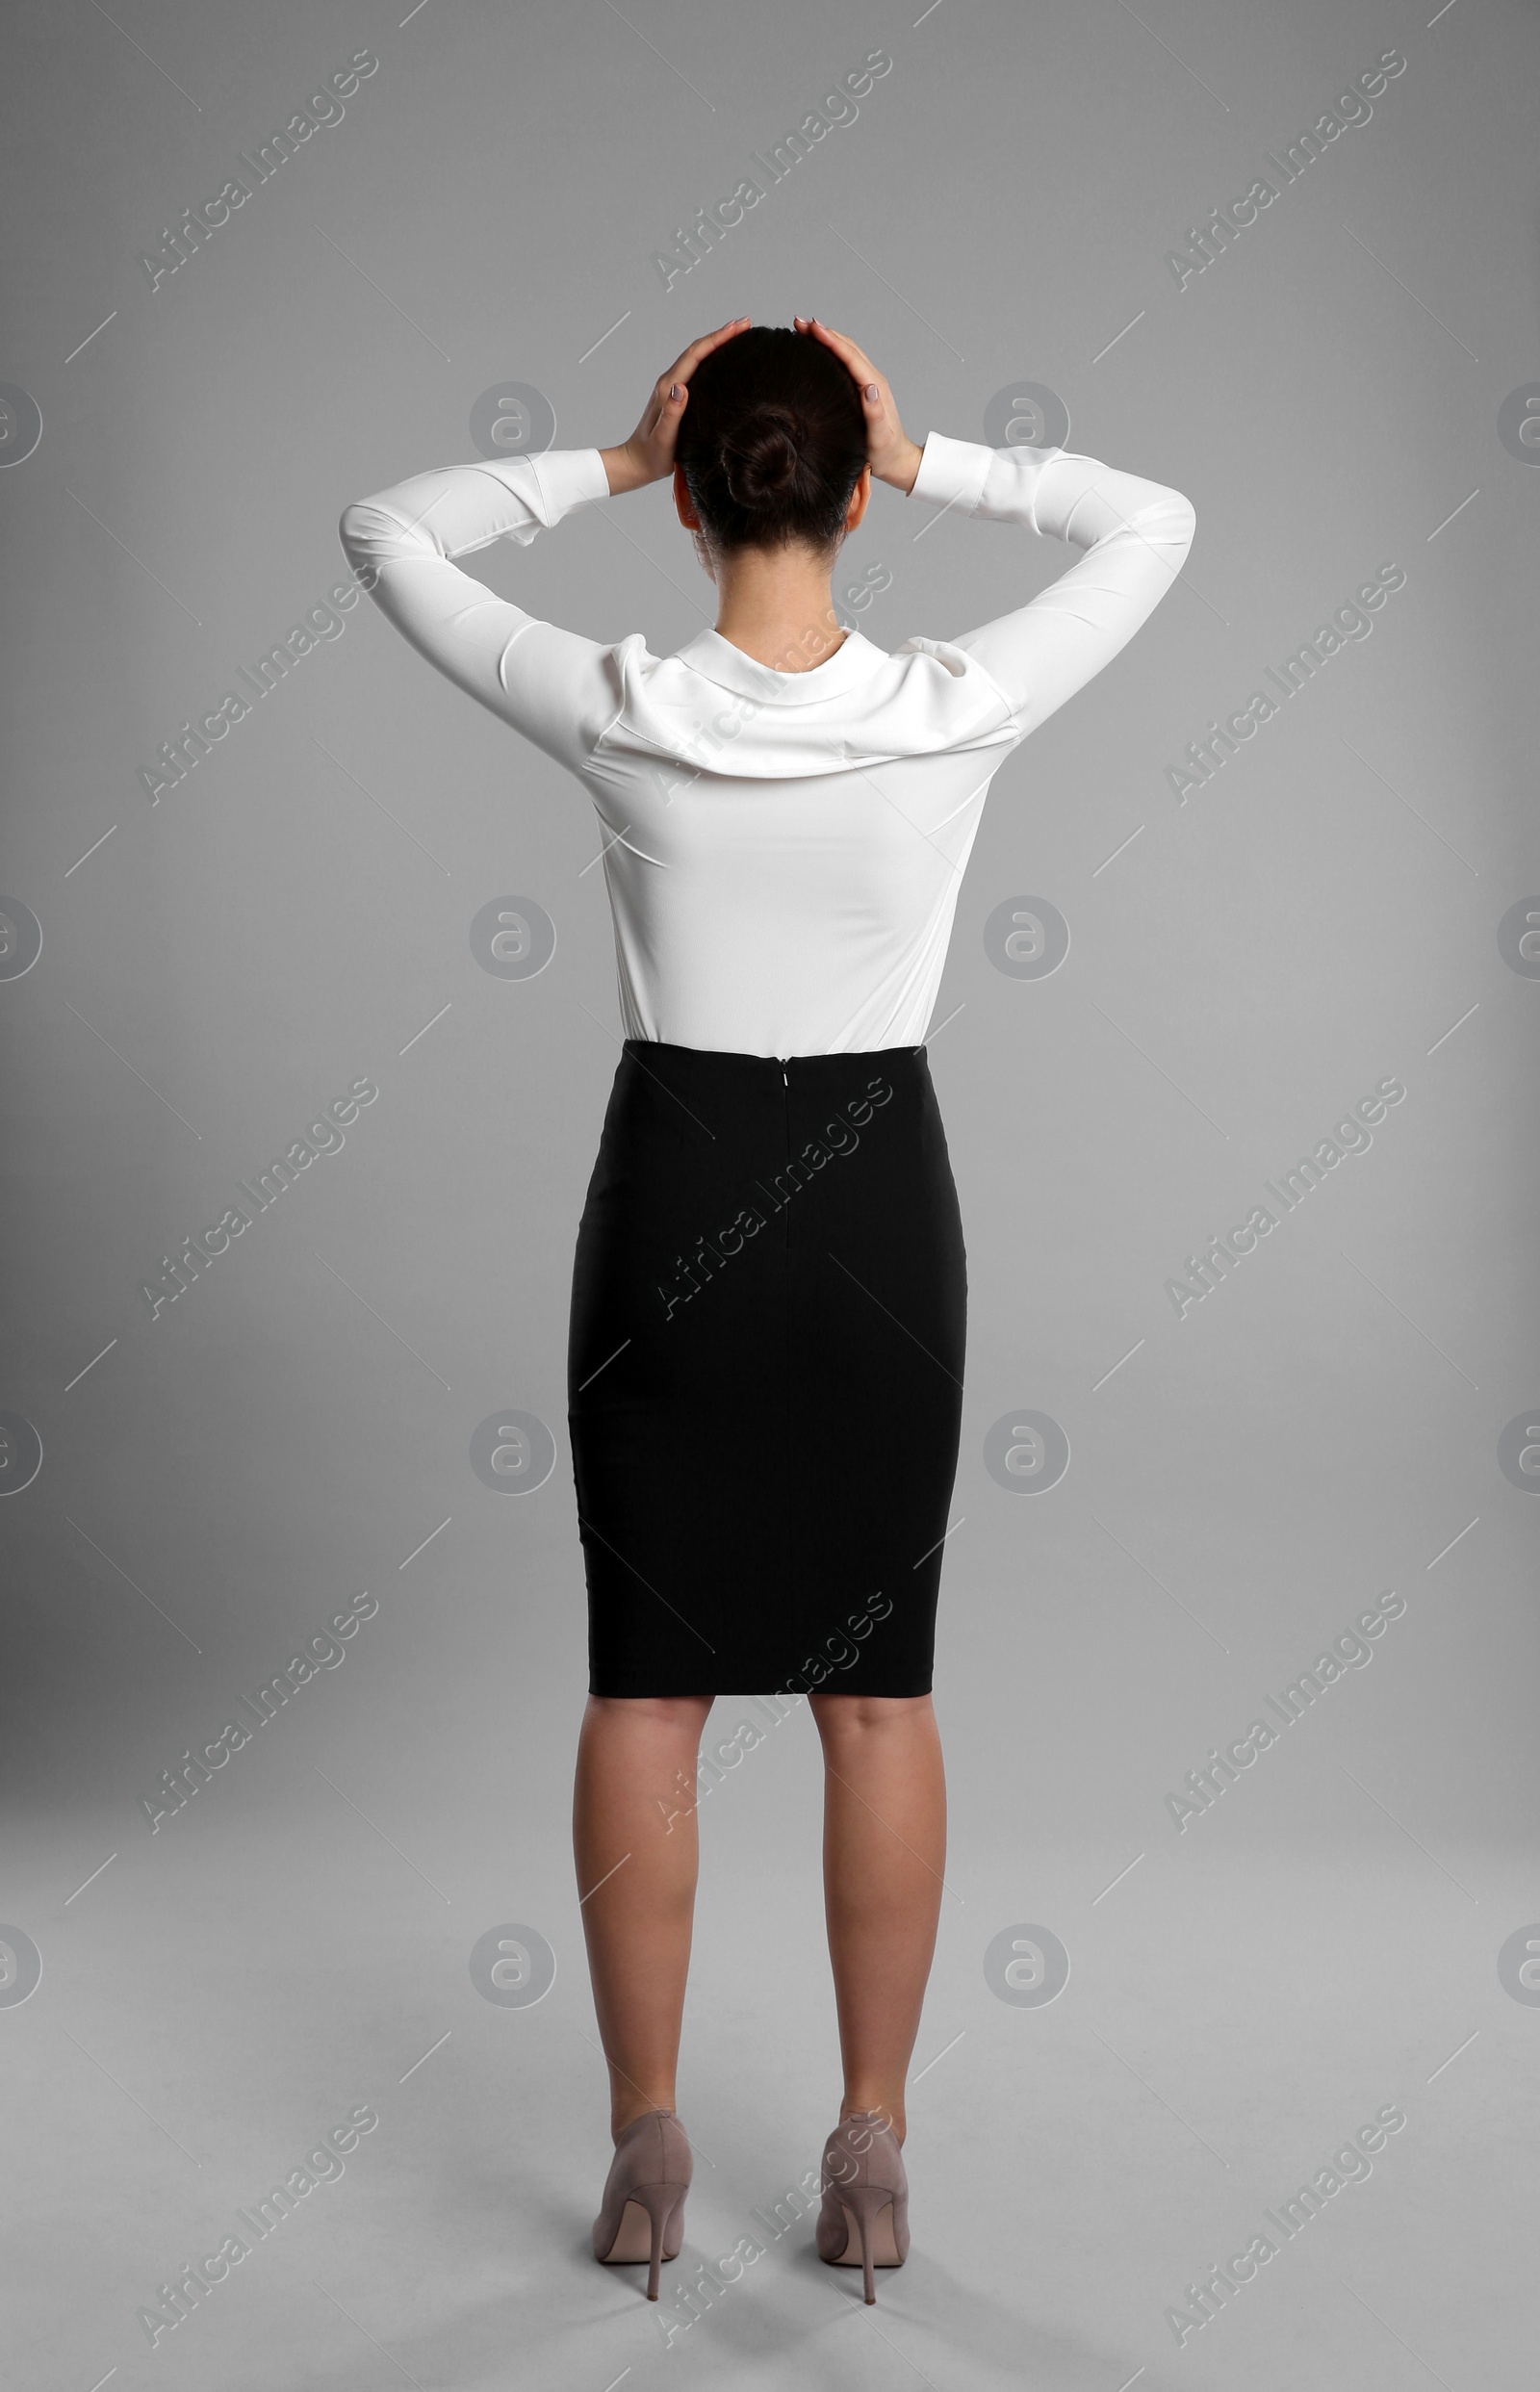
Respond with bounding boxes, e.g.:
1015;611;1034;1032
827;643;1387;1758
0;0;1540;2392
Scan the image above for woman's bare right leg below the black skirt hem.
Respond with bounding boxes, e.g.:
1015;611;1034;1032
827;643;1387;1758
808;1693;947;2144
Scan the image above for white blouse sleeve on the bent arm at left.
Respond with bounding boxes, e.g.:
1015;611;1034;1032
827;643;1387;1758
337;448;619;770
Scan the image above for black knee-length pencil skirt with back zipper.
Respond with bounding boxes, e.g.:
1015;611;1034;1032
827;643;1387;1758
567;1038;968;1696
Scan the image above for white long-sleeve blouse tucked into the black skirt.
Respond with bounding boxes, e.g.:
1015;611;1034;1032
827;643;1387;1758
340;433;1195;1057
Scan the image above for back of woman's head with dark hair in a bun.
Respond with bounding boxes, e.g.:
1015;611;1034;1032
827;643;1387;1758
675;325;865;553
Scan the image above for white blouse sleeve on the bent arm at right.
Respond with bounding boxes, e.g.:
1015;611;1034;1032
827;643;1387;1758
909;433;1198;736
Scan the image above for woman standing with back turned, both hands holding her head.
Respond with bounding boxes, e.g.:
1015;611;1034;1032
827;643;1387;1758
342;316;1195;2302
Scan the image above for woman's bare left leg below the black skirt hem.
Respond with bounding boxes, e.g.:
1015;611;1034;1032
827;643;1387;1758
572;1693;710;2141
